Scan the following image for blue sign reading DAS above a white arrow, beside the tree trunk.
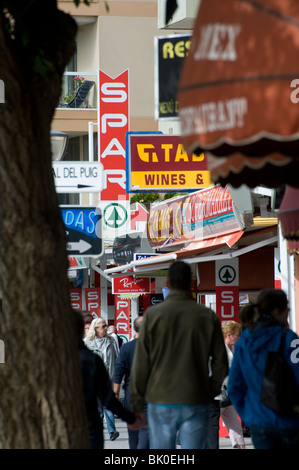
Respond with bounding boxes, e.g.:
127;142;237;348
60;206;103;256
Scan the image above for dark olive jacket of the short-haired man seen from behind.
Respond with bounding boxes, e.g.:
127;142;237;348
130;290;228;412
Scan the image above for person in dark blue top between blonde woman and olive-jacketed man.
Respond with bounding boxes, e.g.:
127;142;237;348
113;316;149;449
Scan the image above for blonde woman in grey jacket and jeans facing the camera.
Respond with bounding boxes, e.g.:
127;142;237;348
84;317;119;441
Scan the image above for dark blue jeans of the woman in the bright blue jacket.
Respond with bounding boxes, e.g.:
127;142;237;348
250;426;299;449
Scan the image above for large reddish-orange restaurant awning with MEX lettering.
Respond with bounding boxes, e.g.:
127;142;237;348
178;0;299;187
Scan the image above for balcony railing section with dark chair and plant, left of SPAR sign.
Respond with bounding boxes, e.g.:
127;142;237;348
58;71;98;109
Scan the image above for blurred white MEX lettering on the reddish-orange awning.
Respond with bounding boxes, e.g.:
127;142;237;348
194;23;241;61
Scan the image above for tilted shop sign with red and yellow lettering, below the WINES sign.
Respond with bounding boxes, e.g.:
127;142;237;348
147;186;245;247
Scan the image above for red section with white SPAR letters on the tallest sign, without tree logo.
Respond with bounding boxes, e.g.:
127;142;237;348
98;70;129;201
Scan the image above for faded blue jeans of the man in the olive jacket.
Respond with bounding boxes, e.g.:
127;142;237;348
147;403;208;449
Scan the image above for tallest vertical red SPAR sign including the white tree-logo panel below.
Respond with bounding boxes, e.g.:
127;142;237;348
98;70;130;238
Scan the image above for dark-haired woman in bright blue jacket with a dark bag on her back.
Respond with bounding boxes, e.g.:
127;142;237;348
228;289;299;449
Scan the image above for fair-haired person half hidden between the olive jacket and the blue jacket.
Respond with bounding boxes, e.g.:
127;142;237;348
220;320;245;449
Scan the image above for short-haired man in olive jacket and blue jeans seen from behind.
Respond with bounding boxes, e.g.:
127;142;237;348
130;261;228;449
